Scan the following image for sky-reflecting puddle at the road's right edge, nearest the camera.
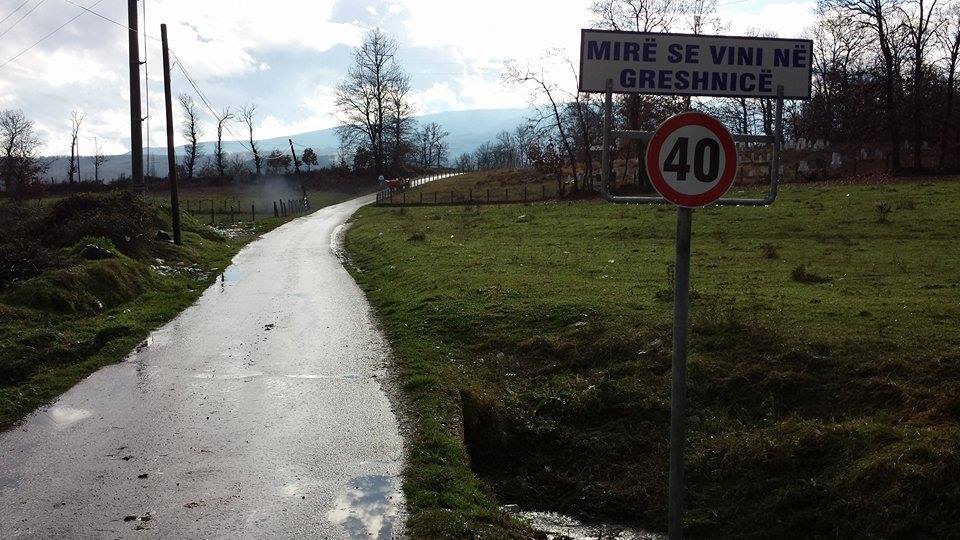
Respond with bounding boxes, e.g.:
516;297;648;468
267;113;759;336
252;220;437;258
327;475;400;540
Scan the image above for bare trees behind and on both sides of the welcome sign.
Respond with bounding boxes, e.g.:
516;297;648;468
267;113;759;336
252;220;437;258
498;0;960;189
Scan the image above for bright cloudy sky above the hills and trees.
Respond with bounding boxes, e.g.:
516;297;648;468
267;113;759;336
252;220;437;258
0;0;815;155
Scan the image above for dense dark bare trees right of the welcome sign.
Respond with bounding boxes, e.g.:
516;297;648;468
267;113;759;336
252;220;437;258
791;0;960;172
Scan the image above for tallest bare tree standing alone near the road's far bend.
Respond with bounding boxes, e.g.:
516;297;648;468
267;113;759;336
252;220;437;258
335;28;405;175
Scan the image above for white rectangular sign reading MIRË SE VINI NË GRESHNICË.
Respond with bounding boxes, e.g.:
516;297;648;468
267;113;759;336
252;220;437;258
580;30;813;99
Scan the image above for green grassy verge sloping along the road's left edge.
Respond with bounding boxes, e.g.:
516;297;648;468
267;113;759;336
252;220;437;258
0;190;341;429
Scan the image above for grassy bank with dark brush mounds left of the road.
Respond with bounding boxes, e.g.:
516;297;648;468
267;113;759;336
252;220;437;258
0;191;347;429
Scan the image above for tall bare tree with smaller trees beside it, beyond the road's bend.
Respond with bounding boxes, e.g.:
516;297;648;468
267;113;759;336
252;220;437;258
335;28;450;176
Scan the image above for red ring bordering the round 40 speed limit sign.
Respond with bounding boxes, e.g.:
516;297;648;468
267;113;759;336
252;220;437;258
646;112;737;208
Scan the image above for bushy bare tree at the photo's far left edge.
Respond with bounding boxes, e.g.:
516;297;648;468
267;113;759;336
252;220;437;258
0;109;47;200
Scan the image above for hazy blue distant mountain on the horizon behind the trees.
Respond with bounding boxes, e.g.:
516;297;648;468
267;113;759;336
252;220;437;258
46;109;531;182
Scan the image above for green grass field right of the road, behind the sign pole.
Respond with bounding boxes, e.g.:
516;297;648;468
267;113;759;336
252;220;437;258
347;181;960;537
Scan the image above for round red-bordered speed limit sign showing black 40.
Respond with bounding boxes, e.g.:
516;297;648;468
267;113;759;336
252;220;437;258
647;112;737;208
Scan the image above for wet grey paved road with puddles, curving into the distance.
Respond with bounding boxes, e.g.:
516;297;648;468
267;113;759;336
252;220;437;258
0;197;403;538
